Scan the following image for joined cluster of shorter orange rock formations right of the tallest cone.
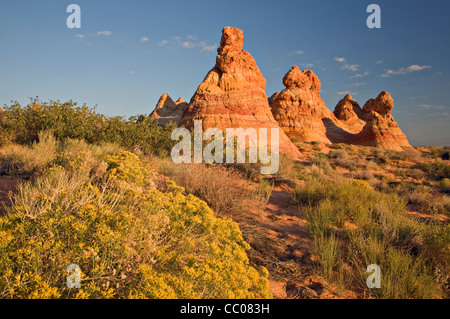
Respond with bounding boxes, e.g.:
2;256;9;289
272;66;411;150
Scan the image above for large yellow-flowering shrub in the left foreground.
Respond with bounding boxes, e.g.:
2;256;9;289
0;152;270;298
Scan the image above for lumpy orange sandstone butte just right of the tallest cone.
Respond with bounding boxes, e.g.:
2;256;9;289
272;66;335;143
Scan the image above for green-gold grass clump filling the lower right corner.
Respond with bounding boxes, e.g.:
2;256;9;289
292;179;448;298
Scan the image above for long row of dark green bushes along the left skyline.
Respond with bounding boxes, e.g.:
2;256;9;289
0;98;176;156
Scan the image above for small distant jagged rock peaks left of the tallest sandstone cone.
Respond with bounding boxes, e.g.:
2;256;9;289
149;93;188;125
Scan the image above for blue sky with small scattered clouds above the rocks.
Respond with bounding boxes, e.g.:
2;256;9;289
0;0;450;145
